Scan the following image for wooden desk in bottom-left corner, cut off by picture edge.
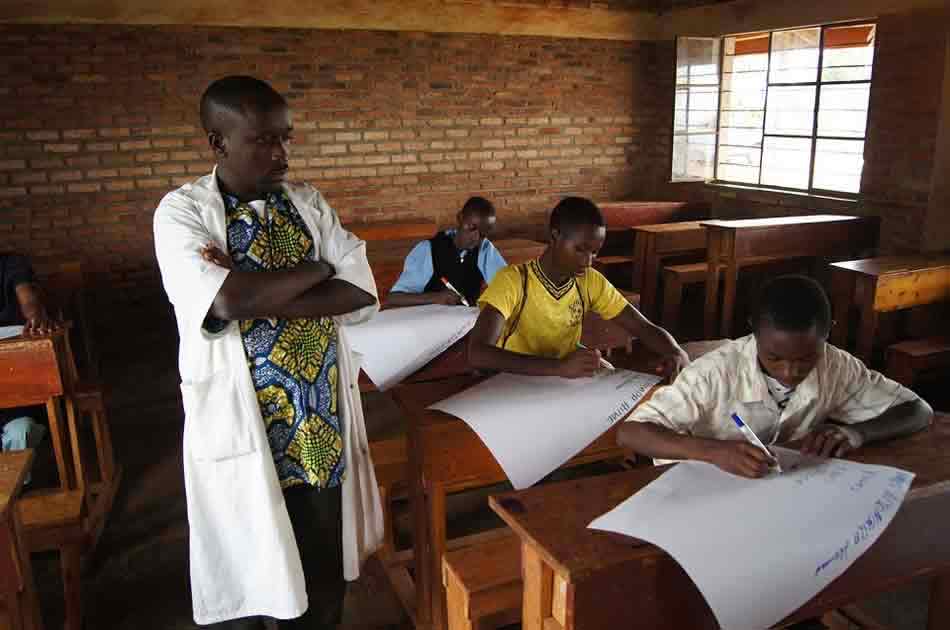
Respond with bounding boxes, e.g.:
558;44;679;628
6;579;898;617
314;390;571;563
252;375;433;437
0;449;43;630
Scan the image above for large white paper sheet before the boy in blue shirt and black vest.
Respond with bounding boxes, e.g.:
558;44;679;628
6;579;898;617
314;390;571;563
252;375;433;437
346;304;478;391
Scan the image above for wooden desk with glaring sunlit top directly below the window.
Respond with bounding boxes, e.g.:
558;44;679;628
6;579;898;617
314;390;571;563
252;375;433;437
702;214;880;338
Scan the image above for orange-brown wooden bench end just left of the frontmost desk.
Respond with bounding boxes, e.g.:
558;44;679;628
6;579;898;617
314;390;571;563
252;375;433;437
442;534;522;630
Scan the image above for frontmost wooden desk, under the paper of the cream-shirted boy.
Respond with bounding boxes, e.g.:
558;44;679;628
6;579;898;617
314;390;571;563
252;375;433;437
489;415;950;630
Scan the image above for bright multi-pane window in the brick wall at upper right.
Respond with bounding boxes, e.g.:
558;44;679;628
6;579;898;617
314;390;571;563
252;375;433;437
673;24;875;194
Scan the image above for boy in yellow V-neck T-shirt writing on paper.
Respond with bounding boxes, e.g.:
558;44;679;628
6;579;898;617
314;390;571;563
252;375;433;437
468;197;689;378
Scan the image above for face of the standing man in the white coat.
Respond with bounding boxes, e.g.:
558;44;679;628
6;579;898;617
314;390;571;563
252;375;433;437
208;105;293;196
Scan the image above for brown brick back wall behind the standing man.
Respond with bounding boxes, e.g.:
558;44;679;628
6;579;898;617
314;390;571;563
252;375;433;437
0;26;672;408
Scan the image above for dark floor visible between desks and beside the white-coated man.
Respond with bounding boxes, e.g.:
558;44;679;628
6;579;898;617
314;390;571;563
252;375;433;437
27;382;927;630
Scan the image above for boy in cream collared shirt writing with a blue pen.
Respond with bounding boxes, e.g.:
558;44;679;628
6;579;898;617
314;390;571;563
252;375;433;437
618;276;933;478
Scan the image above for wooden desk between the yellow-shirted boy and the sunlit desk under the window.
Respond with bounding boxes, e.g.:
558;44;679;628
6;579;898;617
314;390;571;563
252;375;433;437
633;221;706;319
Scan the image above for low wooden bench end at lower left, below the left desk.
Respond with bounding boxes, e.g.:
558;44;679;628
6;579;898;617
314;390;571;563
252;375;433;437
17;490;86;630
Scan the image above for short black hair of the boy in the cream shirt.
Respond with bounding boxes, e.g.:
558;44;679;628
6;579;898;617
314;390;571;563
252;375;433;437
751;275;831;336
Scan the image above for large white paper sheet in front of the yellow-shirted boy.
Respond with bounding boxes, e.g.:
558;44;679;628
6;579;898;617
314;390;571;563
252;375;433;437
430;370;660;490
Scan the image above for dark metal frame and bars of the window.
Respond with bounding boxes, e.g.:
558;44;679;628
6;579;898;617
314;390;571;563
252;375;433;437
684;19;878;200
